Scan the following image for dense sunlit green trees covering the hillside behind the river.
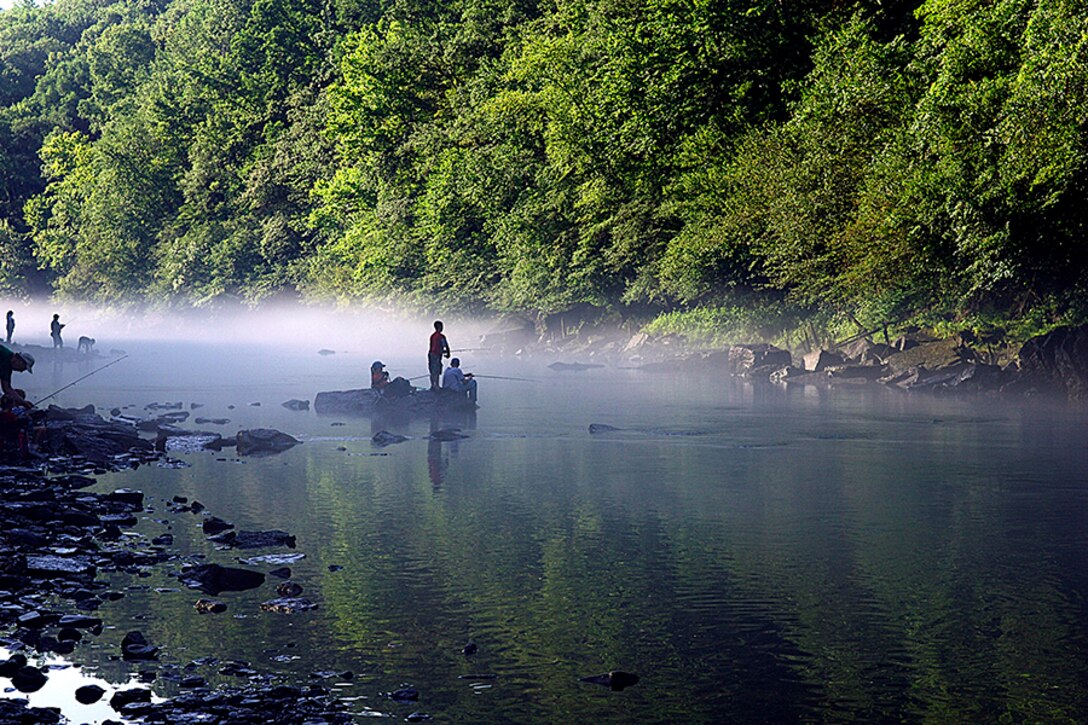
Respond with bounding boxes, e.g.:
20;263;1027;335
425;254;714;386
0;0;1088;323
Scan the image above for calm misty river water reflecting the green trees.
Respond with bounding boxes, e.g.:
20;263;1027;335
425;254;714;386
6;343;1088;723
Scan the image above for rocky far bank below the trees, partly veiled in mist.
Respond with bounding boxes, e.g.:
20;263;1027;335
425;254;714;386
481;315;1088;401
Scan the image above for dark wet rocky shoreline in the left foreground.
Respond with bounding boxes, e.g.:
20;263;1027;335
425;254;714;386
0;407;353;724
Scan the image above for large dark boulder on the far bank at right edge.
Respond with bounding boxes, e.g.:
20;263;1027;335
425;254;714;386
1018;324;1088;400
